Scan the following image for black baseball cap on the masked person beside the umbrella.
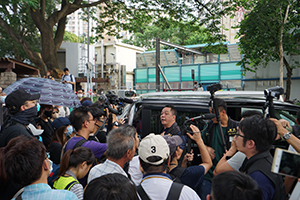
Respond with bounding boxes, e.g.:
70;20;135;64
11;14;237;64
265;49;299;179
5;89;40;111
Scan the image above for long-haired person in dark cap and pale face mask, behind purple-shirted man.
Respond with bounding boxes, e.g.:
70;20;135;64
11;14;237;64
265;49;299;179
47;117;73;164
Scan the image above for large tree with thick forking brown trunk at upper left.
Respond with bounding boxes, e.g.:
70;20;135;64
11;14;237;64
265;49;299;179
0;0;106;74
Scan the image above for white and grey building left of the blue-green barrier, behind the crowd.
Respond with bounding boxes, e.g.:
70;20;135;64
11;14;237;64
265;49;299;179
57;41;144;90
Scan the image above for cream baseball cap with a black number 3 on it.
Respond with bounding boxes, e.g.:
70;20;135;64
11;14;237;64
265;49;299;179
138;133;170;165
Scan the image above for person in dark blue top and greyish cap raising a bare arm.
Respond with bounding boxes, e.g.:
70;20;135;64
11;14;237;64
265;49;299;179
163;125;212;192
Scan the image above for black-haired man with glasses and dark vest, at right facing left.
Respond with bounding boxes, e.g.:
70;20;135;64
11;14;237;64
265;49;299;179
236;115;285;200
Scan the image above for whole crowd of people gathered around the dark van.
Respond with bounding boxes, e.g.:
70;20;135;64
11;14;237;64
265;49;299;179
0;79;300;200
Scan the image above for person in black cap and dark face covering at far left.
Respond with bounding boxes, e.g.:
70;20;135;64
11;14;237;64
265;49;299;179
0;89;40;147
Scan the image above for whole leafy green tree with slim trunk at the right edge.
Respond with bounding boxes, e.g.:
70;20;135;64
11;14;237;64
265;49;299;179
238;0;300;99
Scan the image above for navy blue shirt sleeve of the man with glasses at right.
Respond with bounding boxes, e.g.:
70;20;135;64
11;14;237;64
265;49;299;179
250;171;275;200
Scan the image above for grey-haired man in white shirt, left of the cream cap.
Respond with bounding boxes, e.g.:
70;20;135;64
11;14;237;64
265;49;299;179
88;125;139;183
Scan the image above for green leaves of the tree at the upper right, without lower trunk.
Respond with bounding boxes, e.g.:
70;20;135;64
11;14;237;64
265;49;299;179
238;0;300;70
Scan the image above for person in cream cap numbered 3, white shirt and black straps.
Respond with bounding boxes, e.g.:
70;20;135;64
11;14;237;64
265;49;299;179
137;133;200;200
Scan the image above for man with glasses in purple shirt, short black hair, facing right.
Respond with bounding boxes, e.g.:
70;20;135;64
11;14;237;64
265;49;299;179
64;106;106;161
